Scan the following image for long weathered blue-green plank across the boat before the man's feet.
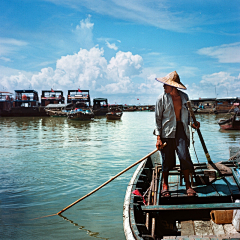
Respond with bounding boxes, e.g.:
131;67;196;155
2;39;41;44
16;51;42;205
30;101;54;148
141;203;240;211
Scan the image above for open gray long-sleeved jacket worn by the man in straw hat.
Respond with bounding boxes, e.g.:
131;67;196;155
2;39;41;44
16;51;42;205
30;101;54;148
153;91;190;146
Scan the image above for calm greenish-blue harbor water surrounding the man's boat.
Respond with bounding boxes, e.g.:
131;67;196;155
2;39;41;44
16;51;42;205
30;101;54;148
0;112;240;240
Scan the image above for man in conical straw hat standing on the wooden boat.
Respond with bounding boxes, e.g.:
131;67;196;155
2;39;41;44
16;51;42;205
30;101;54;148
154;71;200;197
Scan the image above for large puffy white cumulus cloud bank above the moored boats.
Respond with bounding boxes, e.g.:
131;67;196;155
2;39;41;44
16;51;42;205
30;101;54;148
0;46;143;94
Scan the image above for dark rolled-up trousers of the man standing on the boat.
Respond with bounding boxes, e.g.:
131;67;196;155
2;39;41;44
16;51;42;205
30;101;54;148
161;122;193;172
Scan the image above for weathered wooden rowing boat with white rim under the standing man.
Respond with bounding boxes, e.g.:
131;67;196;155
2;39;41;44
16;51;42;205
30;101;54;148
123;148;240;240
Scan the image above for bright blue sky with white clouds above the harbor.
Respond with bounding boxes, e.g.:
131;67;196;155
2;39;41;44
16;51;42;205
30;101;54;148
0;0;240;104
